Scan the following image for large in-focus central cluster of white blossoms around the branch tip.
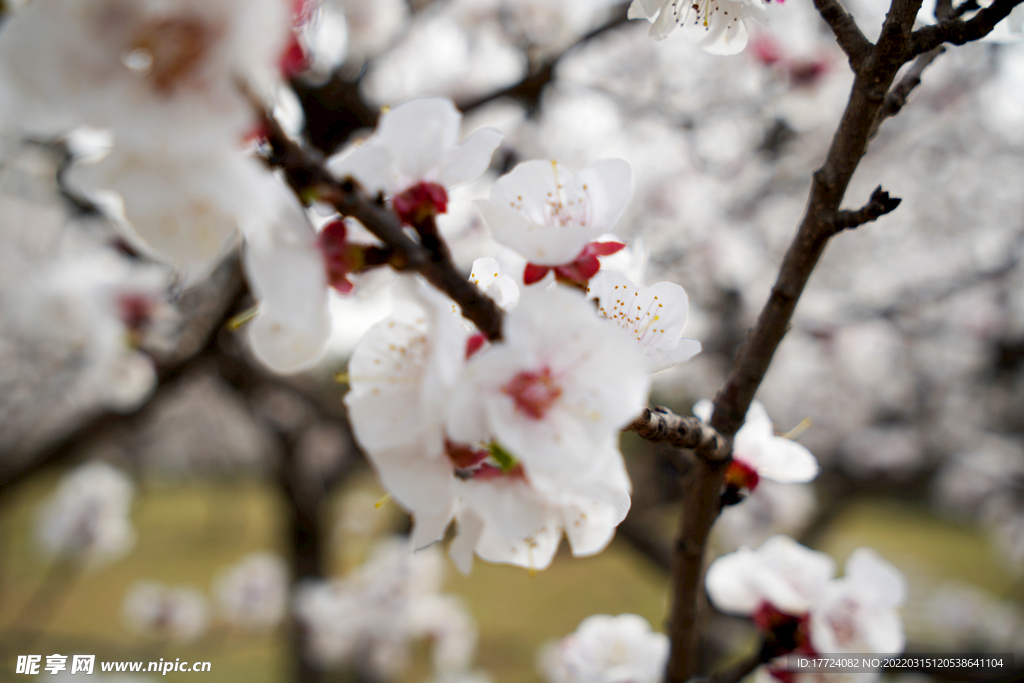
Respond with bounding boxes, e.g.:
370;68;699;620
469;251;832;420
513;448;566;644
330;99;700;571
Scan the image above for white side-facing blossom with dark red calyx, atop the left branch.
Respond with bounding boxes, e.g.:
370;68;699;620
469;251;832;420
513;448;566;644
328;97;503;225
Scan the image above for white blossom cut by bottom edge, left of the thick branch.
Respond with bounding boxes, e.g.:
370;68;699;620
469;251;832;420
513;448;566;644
540;614;669;683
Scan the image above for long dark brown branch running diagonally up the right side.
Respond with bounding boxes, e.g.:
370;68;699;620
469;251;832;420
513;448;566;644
667;0;937;683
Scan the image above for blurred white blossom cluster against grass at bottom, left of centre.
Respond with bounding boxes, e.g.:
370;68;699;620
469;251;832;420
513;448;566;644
294;539;476;680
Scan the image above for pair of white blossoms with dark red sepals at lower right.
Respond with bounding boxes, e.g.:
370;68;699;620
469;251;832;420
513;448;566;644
707;536;907;681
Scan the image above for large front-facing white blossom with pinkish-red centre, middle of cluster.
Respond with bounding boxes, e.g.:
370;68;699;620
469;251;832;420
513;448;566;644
446;288;649;486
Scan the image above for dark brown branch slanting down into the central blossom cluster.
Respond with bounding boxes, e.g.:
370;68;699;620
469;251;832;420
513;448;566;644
263;108;502;341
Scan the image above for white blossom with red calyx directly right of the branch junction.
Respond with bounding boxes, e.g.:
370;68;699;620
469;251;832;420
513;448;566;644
693;398;818;489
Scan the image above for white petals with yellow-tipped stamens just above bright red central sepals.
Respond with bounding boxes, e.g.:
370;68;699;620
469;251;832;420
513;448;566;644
475;159;633;265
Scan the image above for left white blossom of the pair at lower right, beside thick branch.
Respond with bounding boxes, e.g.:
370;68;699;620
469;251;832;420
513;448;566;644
706;536;836;616
